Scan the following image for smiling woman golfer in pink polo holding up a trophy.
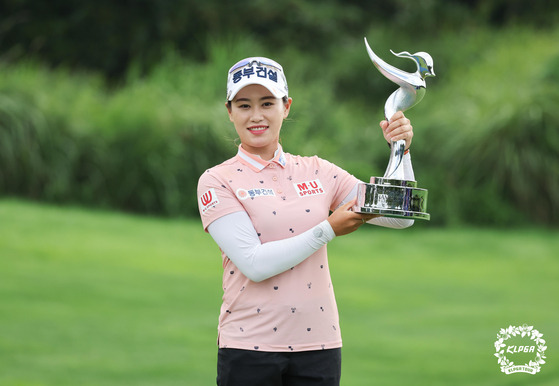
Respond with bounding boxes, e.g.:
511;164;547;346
198;57;414;386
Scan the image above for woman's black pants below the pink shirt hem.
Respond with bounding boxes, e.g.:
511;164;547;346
217;348;342;386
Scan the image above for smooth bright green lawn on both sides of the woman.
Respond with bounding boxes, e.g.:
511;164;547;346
0;199;559;386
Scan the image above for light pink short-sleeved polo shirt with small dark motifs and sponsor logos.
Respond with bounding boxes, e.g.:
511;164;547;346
198;146;358;351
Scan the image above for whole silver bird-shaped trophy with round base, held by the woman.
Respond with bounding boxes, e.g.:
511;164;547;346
354;38;435;220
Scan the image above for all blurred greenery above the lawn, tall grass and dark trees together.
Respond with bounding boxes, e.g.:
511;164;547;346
0;0;559;226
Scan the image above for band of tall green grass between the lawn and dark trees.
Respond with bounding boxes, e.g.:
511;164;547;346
0;28;559;225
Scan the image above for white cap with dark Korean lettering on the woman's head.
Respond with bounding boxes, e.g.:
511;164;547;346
227;57;288;101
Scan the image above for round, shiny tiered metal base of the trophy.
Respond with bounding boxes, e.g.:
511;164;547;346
354;177;430;220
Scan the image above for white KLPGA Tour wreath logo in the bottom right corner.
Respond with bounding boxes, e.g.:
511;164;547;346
494;325;547;374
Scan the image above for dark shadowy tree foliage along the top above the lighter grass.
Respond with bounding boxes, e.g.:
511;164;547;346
4;0;559;79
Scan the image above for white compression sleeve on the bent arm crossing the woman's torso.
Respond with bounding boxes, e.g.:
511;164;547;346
208;211;335;282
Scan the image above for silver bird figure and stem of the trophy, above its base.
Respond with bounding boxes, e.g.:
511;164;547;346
365;38;435;179
